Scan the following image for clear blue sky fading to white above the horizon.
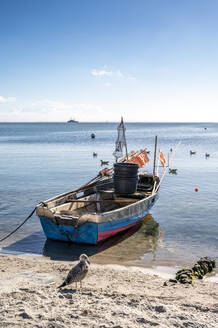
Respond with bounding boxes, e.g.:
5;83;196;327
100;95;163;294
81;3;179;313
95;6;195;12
0;0;218;122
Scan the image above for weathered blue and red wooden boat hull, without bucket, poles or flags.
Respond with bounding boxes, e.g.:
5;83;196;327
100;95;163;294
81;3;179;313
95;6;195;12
36;173;159;244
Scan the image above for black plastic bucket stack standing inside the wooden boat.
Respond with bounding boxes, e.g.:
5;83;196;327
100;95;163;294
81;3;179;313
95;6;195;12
113;163;139;195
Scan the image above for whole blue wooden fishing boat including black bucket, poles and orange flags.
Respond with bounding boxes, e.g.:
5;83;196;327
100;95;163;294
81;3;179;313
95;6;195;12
36;119;164;245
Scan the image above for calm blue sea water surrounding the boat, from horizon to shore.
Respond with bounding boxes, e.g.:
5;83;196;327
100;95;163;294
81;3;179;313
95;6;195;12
0;123;218;266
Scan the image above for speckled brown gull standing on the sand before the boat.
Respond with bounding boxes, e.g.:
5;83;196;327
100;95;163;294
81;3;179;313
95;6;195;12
58;254;90;288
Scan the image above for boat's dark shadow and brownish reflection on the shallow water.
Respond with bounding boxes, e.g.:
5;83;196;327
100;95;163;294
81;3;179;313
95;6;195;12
43;214;162;263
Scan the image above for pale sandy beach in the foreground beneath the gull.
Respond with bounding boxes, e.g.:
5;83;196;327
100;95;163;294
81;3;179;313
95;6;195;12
0;254;218;328
